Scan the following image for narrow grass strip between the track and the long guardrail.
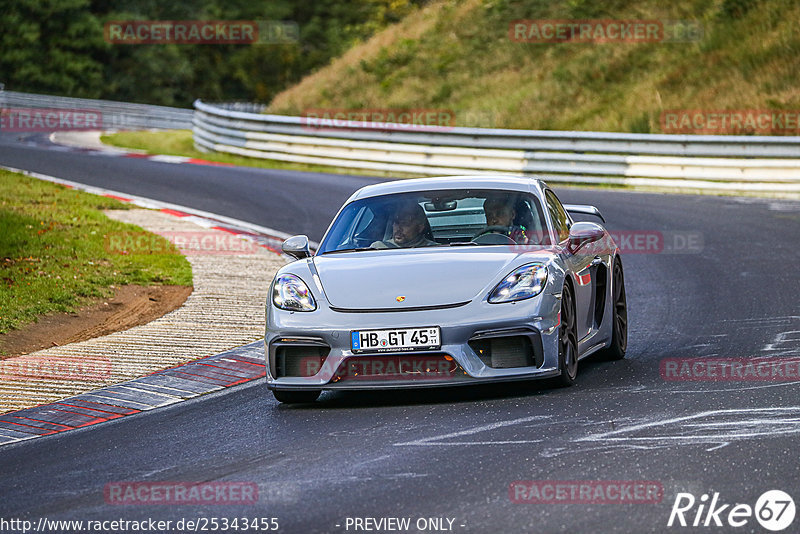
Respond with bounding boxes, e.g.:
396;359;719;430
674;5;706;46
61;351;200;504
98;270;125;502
100;130;422;178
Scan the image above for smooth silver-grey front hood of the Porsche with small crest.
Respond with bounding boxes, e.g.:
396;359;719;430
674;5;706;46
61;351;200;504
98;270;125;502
313;247;535;311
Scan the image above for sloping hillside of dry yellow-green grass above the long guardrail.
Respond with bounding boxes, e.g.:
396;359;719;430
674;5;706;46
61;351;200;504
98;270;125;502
267;0;800;133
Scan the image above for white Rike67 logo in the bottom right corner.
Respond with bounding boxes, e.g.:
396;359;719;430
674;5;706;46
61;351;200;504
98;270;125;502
667;490;795;532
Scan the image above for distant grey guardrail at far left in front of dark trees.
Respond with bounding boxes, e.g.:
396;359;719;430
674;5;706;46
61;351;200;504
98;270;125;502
0;90;193;130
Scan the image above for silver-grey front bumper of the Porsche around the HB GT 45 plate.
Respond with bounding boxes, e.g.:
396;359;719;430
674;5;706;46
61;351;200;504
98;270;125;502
264;293;561;390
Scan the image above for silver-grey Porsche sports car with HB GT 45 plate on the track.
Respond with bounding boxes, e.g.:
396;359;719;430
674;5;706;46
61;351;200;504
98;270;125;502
264;176;627;403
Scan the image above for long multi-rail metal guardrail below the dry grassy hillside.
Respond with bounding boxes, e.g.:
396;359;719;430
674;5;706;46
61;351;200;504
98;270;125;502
192;100;800;192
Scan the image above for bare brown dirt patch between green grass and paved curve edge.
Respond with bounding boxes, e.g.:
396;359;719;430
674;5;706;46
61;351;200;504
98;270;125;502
0;285;192;359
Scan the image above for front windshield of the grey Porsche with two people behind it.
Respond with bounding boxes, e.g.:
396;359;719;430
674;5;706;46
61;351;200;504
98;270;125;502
318;189;549;254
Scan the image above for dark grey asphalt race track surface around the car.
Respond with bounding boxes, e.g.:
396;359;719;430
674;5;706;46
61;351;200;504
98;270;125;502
0;131;800;533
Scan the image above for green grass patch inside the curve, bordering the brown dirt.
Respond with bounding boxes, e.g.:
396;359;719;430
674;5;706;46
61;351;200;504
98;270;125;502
0;170;192;333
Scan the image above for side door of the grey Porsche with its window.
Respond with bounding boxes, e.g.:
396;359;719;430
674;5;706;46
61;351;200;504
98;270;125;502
545;189;594;341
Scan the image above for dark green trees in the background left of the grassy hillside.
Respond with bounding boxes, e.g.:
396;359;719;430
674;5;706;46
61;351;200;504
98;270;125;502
0;0;424;106
